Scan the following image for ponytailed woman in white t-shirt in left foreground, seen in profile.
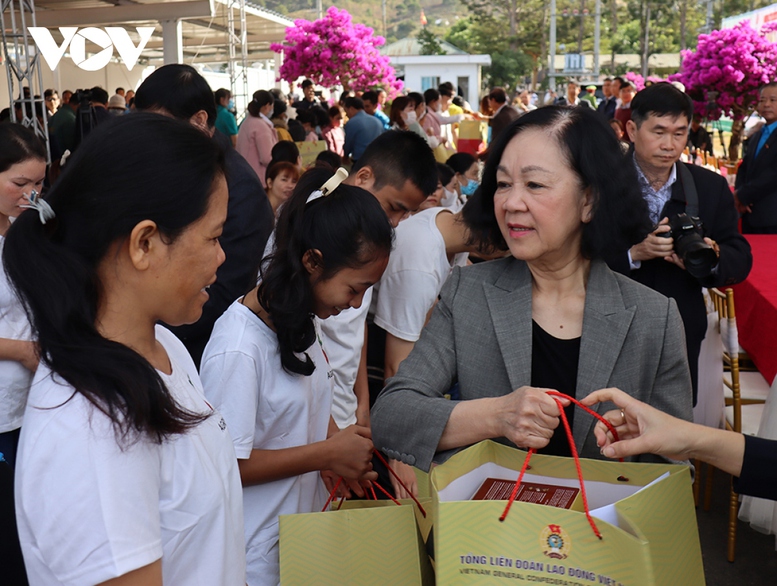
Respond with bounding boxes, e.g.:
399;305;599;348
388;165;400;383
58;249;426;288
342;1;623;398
3;114;245;586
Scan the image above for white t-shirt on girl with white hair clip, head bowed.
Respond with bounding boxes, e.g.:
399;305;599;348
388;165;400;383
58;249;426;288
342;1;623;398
200;301;332;586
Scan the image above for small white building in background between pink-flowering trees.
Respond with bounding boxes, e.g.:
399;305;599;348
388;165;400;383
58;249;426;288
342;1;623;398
381;38;491;109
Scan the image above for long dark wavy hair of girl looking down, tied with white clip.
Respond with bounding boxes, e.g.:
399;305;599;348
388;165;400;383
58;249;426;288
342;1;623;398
258;168;394;376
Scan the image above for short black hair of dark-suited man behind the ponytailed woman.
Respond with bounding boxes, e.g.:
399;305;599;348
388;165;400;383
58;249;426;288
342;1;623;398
135;63;216;128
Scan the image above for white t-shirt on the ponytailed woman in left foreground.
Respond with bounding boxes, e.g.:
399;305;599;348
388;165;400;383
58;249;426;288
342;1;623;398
16;326;245;586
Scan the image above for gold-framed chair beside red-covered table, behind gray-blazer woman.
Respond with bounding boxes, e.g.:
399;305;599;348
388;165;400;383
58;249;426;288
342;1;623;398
705;289;769;562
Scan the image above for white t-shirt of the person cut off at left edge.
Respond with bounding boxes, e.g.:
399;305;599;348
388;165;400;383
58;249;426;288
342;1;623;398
0;236;32;433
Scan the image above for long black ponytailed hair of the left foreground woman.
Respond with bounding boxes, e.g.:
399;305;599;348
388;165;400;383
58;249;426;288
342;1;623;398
3;113;224;442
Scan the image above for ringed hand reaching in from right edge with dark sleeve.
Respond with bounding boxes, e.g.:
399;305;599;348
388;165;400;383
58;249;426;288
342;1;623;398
581;388;696;460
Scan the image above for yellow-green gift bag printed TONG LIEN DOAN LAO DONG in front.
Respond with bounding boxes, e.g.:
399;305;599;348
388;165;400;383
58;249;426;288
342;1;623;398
431;441;704;586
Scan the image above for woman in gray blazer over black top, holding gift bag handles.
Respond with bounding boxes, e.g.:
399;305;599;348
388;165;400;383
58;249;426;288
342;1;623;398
372;106;692;470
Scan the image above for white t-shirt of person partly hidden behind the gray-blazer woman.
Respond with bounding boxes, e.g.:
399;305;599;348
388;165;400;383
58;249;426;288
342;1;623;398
375;208;452;342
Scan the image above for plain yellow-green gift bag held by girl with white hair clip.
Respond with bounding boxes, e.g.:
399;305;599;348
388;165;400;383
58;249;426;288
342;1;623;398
280;492;434;586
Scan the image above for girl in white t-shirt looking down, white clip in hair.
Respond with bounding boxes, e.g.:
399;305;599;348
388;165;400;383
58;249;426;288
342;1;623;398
201;168;393;586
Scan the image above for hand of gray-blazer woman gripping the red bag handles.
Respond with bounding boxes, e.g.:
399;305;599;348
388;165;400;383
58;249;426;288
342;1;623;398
494;386;569;449
